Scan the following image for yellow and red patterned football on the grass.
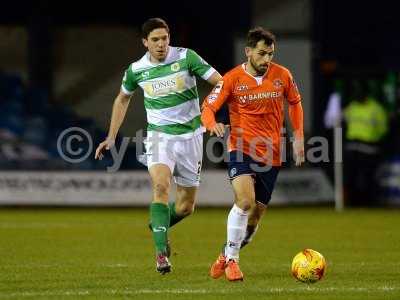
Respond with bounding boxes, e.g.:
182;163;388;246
292;249;326;283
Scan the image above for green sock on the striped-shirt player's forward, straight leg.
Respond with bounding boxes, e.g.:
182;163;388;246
150;203;169;253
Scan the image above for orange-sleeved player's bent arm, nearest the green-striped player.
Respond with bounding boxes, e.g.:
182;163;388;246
201;76;230;137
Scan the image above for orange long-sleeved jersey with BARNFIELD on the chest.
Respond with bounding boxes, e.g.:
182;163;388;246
202;63;303;166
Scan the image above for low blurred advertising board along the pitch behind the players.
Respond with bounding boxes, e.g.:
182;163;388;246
0;169;333;206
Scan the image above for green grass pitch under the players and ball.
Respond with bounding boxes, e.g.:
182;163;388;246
0;208;400;300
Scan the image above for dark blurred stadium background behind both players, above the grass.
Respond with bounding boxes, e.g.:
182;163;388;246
0;0;400;209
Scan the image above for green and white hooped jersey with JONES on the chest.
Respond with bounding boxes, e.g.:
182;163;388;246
121;46;215;139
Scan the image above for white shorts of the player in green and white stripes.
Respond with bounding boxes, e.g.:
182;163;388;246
141;134;203;187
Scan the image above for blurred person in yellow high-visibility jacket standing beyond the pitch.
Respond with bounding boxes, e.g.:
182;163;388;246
343;81;388;206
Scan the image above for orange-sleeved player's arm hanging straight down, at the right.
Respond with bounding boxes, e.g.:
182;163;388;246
286;73;305;166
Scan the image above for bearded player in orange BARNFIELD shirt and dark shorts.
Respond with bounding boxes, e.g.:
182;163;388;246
201;27;304;281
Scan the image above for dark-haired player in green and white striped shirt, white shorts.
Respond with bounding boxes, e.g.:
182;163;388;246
96;18;221;274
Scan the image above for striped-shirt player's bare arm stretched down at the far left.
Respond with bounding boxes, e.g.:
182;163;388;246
95;67;137;159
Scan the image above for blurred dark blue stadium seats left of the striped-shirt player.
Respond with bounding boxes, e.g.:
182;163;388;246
0;71;144;170
